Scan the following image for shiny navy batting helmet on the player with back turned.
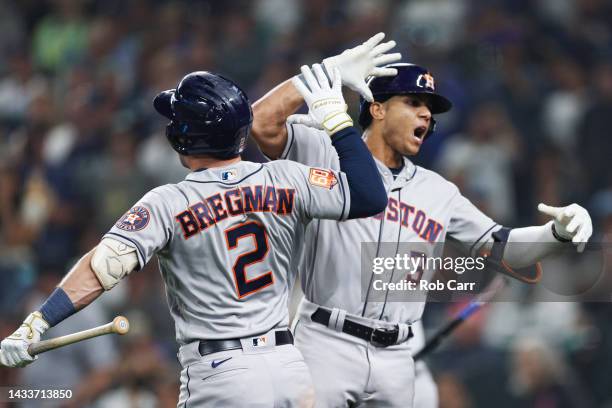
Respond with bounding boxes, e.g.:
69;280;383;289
153;71;253;159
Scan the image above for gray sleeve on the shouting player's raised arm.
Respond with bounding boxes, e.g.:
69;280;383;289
280;124;339;170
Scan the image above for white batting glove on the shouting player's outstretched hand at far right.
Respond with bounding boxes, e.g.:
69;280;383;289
538;203;593;252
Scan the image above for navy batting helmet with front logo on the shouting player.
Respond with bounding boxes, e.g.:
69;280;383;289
359;63;453;136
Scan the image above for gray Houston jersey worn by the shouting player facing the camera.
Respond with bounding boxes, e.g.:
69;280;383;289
281;124;497;323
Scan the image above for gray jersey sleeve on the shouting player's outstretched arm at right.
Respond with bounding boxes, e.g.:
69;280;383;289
447;189;497;247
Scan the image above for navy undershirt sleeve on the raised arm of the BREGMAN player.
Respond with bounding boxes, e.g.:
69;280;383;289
332;126;387;219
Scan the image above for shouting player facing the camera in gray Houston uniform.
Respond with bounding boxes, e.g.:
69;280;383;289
253;34;592;408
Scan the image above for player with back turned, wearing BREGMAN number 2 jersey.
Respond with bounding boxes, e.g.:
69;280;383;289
0;70;387;407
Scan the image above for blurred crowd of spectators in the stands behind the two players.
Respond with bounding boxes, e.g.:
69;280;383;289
0;0;612;408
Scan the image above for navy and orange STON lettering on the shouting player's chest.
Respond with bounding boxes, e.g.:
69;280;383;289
373;197;444;242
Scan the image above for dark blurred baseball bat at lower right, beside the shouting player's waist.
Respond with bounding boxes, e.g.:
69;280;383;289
414;276;506;361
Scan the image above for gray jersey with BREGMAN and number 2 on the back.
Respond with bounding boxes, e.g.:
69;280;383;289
106;159;350;344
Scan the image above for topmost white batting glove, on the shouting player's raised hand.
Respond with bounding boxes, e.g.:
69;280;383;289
323;33;402;102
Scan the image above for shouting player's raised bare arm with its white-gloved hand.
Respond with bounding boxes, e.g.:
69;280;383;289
251;33;402;159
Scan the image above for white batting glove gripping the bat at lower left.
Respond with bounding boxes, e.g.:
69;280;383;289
0;312;49;367
